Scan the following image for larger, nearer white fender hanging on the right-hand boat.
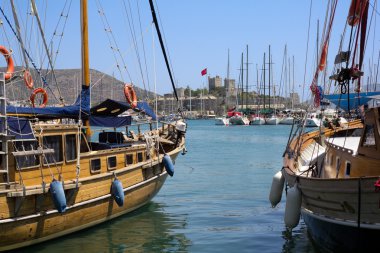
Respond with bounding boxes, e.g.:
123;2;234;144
284;184;302;229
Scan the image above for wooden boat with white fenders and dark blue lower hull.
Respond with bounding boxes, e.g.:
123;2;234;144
270;1;380;252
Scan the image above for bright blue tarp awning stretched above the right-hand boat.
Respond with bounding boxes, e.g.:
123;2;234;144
324;91;380;111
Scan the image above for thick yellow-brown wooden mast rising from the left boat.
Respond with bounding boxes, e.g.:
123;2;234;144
80;0;91;138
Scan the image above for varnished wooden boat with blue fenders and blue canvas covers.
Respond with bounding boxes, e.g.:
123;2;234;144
0;0;186;251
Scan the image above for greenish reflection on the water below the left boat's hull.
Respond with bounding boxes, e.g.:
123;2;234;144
18;202;191;253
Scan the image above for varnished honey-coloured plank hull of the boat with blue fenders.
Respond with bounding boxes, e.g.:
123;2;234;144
0;149;180;251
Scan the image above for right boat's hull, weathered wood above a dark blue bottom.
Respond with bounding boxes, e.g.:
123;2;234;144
283;169;380;252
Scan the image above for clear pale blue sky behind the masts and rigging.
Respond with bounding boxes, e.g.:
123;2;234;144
0;0;380;102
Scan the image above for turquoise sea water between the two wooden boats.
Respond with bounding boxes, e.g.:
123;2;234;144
19;120;319;253
